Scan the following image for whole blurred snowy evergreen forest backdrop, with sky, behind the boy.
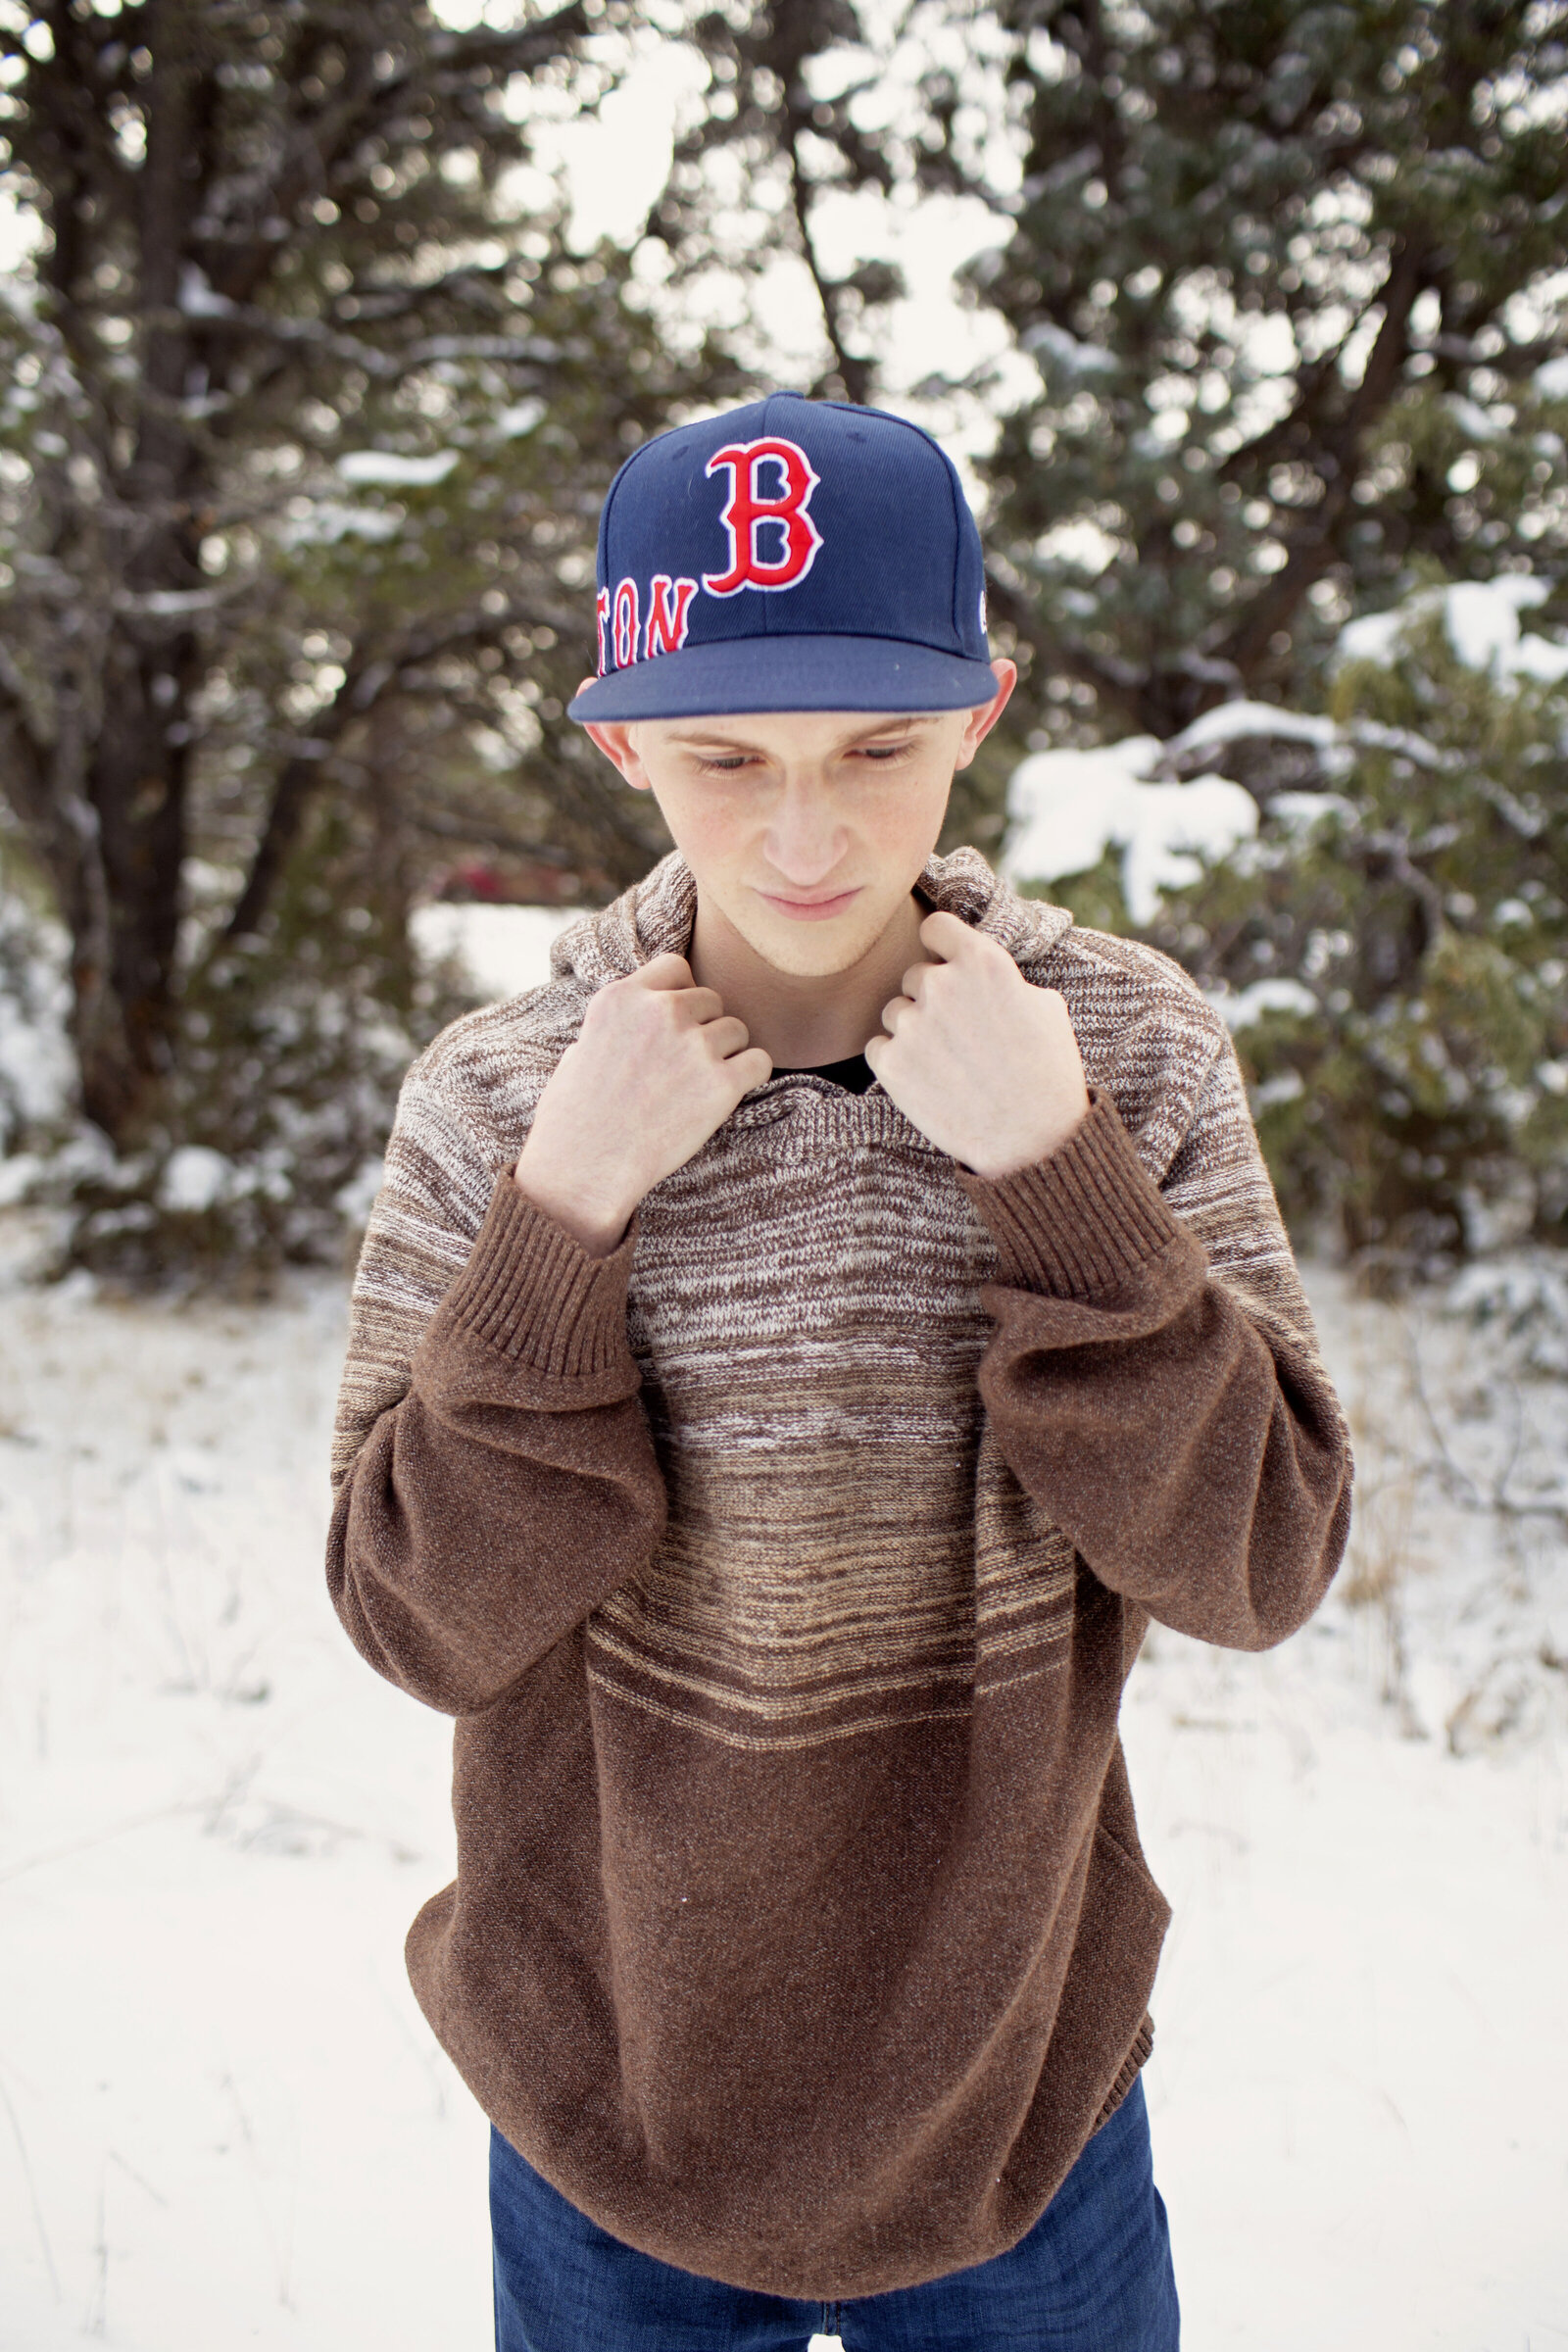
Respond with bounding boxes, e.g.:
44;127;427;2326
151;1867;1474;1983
0;0;1568;1284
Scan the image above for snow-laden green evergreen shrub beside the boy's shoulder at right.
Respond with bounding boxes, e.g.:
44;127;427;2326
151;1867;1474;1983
1006;576;1568;1277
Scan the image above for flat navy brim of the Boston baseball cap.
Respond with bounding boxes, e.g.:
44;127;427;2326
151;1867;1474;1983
566;637;997;719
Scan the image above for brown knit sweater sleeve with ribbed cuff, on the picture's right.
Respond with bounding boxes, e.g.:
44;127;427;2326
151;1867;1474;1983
961;1042;1351;1648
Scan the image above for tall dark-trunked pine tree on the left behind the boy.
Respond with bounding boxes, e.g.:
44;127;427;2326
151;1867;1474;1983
0;0;736;1151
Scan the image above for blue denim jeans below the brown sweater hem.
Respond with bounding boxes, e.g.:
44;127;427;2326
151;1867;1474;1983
489;2082;1180;2352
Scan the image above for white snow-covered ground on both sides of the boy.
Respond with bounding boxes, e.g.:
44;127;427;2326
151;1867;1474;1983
0;1211;1568;2352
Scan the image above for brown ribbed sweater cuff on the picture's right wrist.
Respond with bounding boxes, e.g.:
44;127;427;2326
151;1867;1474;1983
959;1092;1183;1298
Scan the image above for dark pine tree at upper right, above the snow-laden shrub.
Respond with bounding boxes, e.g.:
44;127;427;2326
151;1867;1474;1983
958;0;1568;739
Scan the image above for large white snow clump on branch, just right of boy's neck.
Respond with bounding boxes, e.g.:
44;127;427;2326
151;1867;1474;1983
1002;736;1257;922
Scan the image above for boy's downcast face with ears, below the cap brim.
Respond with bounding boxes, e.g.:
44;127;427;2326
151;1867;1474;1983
588;661;1018;978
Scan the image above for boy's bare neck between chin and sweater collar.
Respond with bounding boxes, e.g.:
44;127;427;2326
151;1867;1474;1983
689;896;929;1070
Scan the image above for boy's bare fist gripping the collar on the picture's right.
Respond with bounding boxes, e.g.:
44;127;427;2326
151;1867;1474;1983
865;915;1089;1178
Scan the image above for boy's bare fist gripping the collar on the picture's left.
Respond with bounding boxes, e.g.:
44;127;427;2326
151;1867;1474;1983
514;955;773;1258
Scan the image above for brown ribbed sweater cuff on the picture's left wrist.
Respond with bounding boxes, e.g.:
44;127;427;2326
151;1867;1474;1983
444;1169;637;1381
